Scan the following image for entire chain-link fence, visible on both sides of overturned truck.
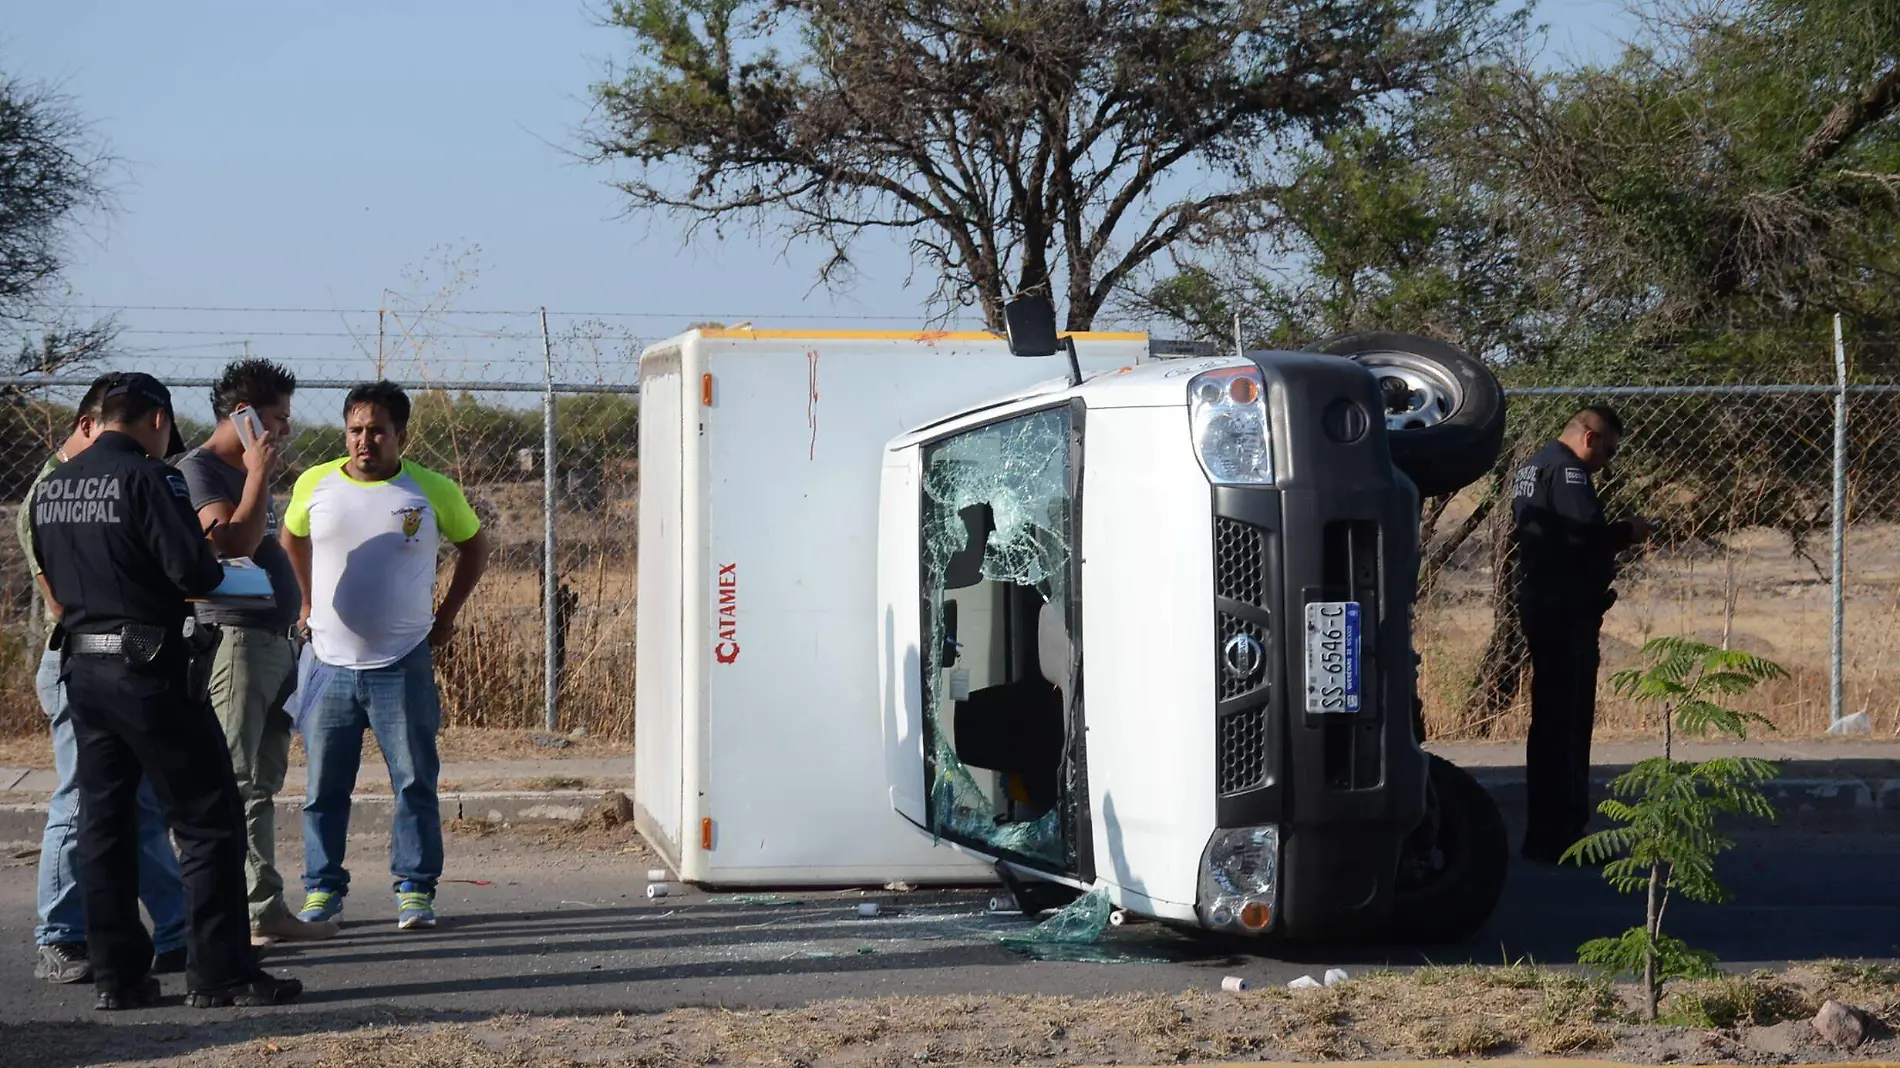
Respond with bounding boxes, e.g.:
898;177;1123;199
0;349;1900;739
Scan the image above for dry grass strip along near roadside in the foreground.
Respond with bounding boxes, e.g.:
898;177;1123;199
8;965;1900;1068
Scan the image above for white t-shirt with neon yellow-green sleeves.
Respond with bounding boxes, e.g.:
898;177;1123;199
283;460;481;671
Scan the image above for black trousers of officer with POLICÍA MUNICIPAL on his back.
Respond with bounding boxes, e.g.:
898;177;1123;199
63;648;257;990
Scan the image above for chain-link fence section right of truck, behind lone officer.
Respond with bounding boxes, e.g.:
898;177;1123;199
1416;384;1900;737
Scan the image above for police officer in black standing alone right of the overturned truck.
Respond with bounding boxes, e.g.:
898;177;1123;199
1511;407;1651;863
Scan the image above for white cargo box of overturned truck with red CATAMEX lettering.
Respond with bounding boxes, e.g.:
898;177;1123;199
635;329;1148;887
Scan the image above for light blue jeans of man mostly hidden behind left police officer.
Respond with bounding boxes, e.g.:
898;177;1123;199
32;652;184;942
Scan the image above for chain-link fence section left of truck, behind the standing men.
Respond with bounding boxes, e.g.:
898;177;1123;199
0;353;638;739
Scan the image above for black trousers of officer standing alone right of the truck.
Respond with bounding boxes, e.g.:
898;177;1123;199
1524;606;1604;851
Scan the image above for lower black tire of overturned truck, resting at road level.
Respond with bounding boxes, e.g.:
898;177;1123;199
1389;756;1511;946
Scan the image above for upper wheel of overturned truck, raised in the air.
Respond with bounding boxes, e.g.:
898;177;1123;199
1317;333;1505;498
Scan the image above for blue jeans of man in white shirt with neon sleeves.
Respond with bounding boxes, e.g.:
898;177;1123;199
298;642;443;893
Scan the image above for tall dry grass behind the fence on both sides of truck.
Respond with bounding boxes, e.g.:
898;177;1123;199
11;494;1900;741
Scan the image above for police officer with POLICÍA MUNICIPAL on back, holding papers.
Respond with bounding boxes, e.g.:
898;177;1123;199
32;374;302;1009
